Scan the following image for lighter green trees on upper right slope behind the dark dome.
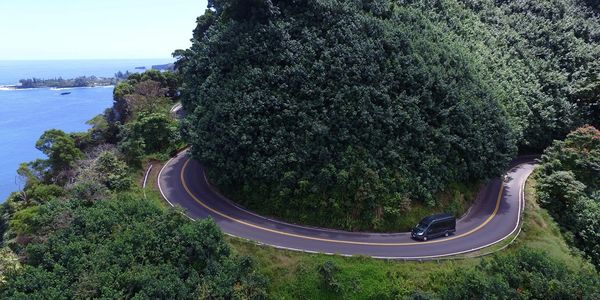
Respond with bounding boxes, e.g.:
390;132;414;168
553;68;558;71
410;0;600;152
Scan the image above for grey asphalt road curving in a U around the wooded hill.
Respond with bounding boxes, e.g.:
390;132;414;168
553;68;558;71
158;151;534;259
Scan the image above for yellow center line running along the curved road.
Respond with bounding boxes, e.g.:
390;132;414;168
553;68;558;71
179;158;503;246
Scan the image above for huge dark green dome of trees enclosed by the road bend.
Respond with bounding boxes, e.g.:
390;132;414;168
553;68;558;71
176;0;517;229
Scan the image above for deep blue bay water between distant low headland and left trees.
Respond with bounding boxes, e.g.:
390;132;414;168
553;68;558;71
0;87;113;200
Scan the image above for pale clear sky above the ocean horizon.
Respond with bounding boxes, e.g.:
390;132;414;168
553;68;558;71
0;0;207;60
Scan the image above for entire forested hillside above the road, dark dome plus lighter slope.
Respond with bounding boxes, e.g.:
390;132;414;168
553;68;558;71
176;0;600;230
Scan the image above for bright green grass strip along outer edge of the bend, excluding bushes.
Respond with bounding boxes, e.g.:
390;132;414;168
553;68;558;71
227;178;592;299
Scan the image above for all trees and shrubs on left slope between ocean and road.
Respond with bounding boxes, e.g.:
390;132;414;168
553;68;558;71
0;71;266;299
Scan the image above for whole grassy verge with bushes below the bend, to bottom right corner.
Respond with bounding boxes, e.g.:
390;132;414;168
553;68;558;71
227;146;600;300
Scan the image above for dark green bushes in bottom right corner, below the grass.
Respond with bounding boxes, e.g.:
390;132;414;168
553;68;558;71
440;248;600;299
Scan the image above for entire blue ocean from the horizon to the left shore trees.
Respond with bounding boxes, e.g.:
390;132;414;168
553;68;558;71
0;58;172;202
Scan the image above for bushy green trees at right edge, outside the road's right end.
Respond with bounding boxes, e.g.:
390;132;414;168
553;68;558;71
535;126;600;268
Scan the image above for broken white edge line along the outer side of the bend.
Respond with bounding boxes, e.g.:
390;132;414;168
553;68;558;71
157;149;531;260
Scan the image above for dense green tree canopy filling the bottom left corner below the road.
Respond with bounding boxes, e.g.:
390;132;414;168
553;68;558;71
0;195;266;299
